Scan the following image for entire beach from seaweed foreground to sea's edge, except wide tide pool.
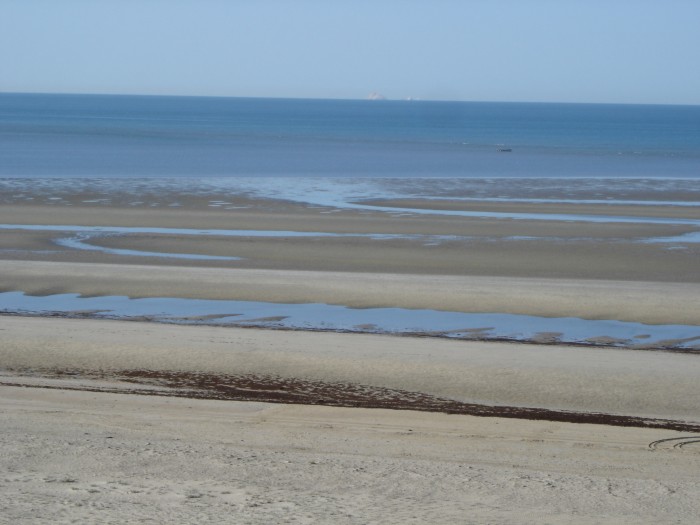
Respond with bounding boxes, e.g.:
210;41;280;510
0;181;700;523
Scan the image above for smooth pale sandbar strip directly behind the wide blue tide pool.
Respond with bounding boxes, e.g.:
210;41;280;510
0;261;700;325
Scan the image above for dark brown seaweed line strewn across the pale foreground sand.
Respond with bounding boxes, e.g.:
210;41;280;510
5;370;700;433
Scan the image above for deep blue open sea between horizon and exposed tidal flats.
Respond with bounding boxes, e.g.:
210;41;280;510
0;93;700;178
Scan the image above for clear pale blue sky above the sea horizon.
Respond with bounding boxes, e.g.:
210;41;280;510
0;0;700;104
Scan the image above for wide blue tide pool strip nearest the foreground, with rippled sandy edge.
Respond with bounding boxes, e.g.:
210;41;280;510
0;292;700;350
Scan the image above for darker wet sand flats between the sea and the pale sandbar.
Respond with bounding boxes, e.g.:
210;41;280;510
0;195;700;283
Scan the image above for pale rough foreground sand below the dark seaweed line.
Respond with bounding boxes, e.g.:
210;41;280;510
0;380;700;524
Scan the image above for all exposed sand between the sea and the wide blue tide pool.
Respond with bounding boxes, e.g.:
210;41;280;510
0;186;700;325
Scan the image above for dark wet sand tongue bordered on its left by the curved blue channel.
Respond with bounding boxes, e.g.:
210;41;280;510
92;235;700;283
